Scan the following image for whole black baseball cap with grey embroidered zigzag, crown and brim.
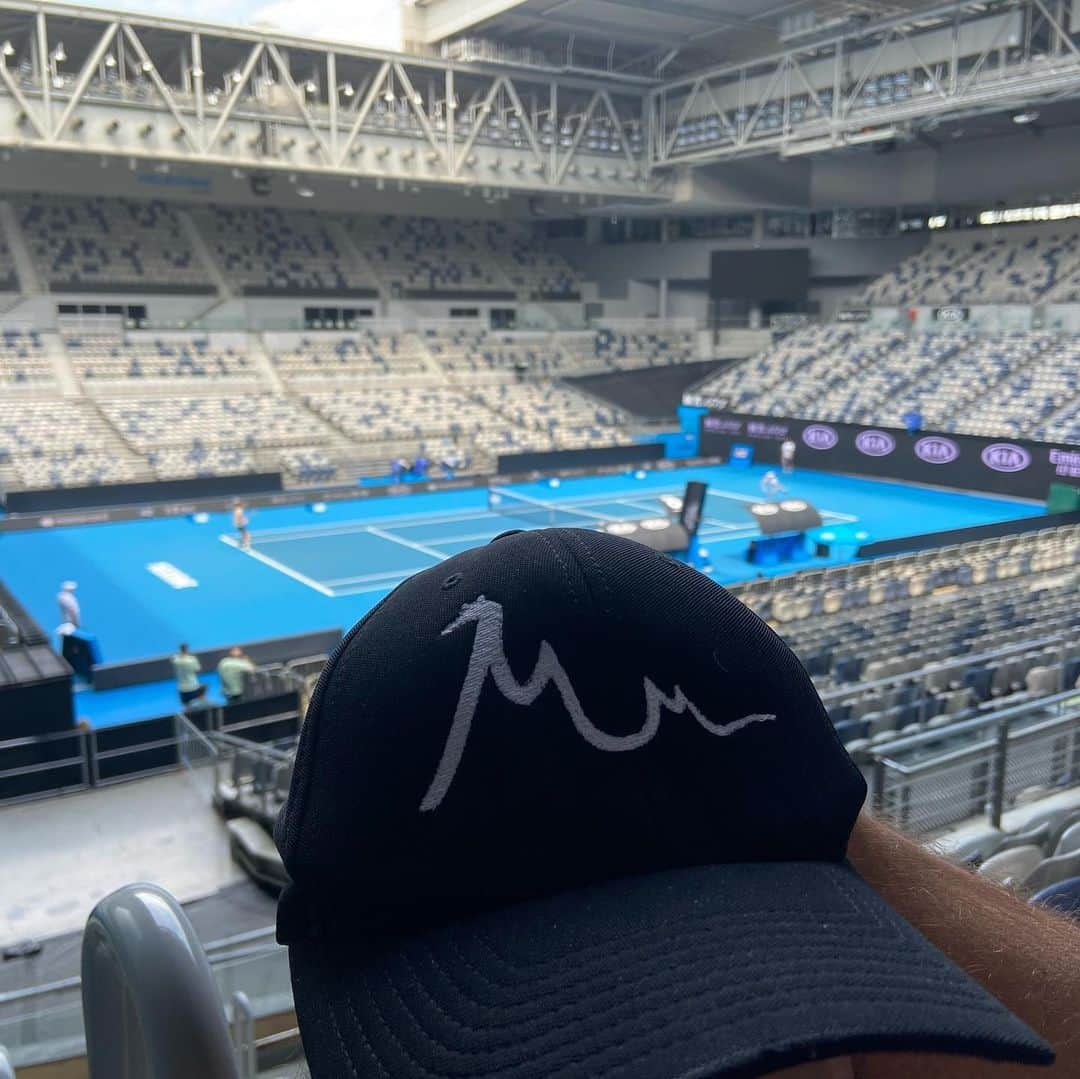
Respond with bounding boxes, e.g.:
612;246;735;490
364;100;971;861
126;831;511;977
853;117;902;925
275;528;1053;1079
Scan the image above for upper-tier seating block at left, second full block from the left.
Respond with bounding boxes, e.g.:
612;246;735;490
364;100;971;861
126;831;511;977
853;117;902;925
191;206;378;299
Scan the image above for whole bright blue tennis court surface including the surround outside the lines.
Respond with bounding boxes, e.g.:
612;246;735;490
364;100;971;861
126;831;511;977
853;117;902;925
0;466;1043;662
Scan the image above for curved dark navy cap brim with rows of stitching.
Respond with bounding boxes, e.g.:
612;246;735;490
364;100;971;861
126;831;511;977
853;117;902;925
289;862;1053;1079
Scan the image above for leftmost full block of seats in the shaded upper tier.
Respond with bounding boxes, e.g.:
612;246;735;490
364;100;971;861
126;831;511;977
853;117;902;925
11;194;214;295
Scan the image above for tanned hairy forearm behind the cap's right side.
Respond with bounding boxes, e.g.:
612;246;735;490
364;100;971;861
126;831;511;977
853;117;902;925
848;813;1080;1079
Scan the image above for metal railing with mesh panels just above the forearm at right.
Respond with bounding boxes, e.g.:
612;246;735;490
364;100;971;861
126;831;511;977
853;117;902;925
868;689;1080;835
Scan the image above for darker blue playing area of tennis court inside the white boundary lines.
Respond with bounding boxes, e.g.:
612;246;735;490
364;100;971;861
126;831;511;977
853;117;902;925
227;473;858;596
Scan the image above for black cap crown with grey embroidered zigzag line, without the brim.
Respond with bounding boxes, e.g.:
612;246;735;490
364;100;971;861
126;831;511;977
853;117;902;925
276;529;865;928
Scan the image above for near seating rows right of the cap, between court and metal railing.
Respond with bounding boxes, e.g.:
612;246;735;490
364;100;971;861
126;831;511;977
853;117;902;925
732;525;1080;741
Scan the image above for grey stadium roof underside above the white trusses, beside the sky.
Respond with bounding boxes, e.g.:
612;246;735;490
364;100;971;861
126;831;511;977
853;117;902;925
415;0;929;79
